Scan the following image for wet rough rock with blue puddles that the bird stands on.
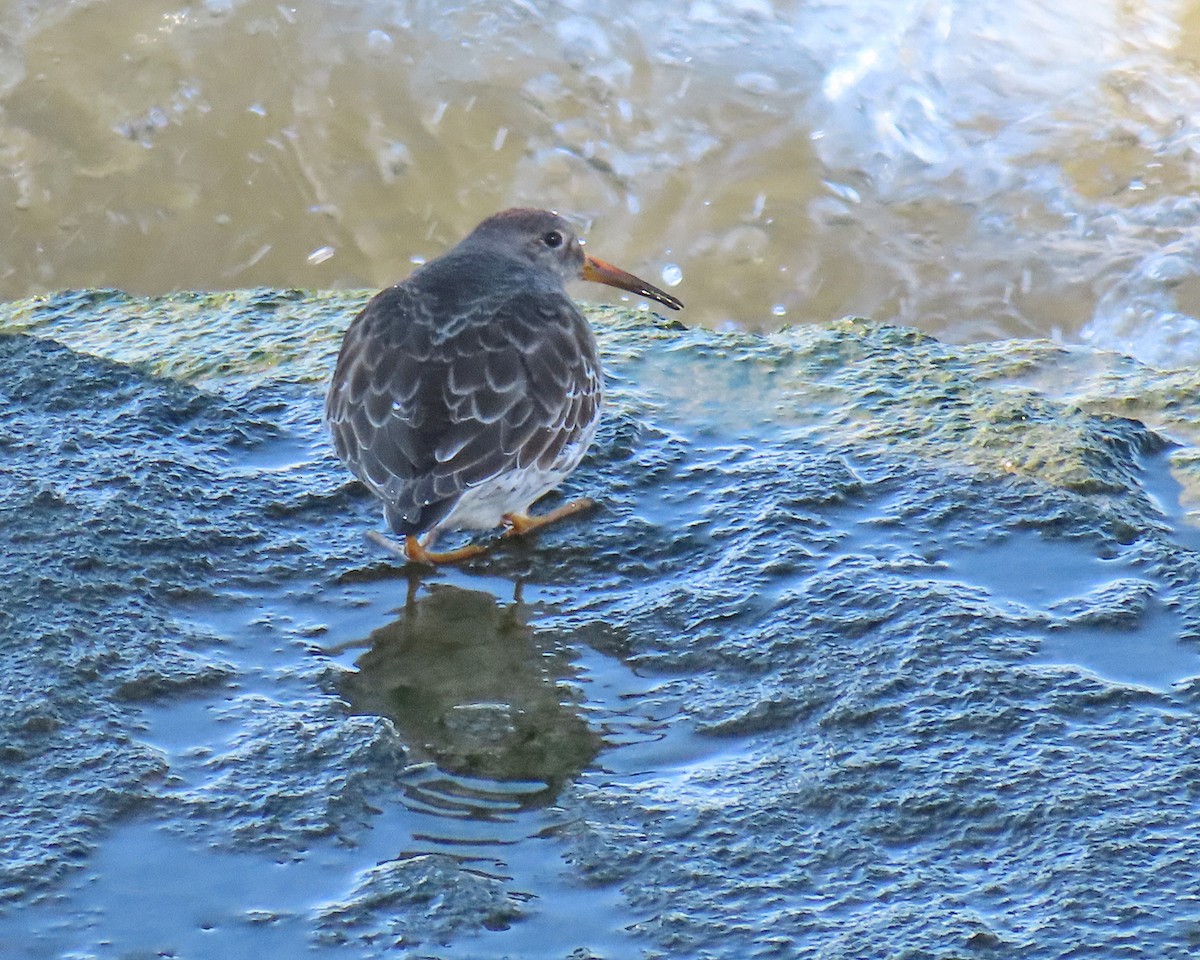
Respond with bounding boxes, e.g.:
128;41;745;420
0;292;1200;958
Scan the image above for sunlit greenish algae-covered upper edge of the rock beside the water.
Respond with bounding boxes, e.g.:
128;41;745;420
0;289;1200;508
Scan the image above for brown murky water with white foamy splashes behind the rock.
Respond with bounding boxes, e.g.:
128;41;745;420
0;0;1200;362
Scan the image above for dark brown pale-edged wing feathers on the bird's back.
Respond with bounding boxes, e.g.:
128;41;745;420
325;283;602;534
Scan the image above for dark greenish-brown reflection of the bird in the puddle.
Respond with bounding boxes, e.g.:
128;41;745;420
341;584;601;805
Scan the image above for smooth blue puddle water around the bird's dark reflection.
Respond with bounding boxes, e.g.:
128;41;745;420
0;572;672;958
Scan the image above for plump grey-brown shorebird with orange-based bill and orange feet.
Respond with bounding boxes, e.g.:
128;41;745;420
325;208;683;564
